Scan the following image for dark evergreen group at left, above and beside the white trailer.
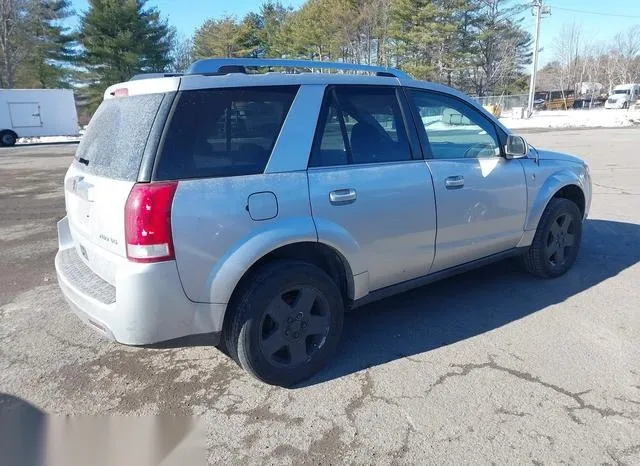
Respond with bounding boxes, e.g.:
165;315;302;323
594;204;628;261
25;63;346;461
0;0;175;111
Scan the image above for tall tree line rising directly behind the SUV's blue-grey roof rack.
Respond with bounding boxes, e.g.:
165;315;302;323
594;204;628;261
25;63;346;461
191;0;532;95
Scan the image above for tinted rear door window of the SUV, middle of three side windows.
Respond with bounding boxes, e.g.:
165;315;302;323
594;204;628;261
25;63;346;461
309;86;411;167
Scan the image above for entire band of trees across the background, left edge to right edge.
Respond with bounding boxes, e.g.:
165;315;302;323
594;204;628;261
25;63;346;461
0;0;640;116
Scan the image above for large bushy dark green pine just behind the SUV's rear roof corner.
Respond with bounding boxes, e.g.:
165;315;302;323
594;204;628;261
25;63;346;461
78;0;174;108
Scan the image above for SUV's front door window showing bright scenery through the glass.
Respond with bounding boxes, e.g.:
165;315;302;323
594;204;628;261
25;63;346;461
410;90;500;159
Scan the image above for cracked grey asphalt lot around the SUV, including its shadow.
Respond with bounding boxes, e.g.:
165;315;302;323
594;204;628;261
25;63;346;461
0;128;640;465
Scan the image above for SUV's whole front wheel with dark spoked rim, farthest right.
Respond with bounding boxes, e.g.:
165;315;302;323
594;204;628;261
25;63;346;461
522;198;582;278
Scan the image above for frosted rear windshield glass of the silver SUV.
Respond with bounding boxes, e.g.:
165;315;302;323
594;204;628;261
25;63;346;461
75;94;165;181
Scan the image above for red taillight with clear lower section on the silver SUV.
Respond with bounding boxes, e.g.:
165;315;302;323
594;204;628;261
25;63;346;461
124;181;178;262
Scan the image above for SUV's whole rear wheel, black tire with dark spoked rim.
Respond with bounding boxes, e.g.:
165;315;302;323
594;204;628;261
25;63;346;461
224;260;344;387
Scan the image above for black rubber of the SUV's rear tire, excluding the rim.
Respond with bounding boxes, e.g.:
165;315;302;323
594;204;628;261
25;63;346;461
229;261;344;386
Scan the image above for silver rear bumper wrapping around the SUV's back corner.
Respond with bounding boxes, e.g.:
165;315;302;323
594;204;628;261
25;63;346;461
55;217;226;345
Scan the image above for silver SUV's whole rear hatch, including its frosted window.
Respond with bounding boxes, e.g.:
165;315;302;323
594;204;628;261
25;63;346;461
64;86;173;285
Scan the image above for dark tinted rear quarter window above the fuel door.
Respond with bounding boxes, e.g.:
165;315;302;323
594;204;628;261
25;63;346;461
154;86;298;180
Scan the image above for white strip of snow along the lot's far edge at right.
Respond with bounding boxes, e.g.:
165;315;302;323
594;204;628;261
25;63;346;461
500;108;640;129
